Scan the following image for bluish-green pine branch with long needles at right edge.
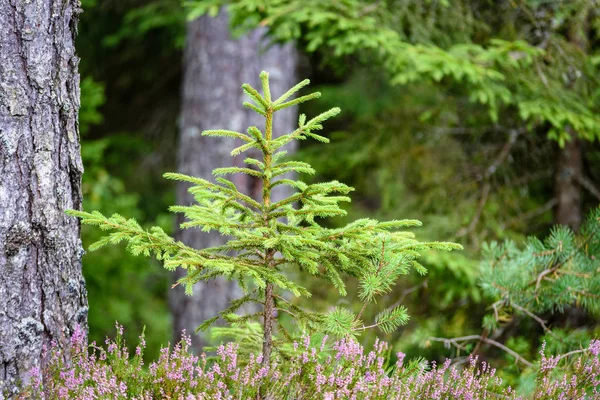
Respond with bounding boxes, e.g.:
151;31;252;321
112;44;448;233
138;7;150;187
481;208;600;315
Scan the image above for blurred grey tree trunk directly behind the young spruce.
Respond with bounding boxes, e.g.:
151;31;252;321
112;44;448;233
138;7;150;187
170;10;297;351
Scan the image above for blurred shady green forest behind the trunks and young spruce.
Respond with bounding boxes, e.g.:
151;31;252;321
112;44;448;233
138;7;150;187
77;0;600;388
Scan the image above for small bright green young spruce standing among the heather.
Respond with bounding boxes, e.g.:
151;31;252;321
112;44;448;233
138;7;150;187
69;72;460;363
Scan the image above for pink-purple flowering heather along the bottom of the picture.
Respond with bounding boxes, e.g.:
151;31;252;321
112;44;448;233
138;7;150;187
20;326;600;400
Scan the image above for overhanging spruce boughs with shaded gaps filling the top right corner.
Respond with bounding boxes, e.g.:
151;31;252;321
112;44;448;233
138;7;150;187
186;0;600;144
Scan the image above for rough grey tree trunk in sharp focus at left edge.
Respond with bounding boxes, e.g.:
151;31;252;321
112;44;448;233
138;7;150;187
0;0;87;398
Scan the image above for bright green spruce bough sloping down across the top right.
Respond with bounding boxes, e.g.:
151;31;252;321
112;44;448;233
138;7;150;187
186;0;600;145
